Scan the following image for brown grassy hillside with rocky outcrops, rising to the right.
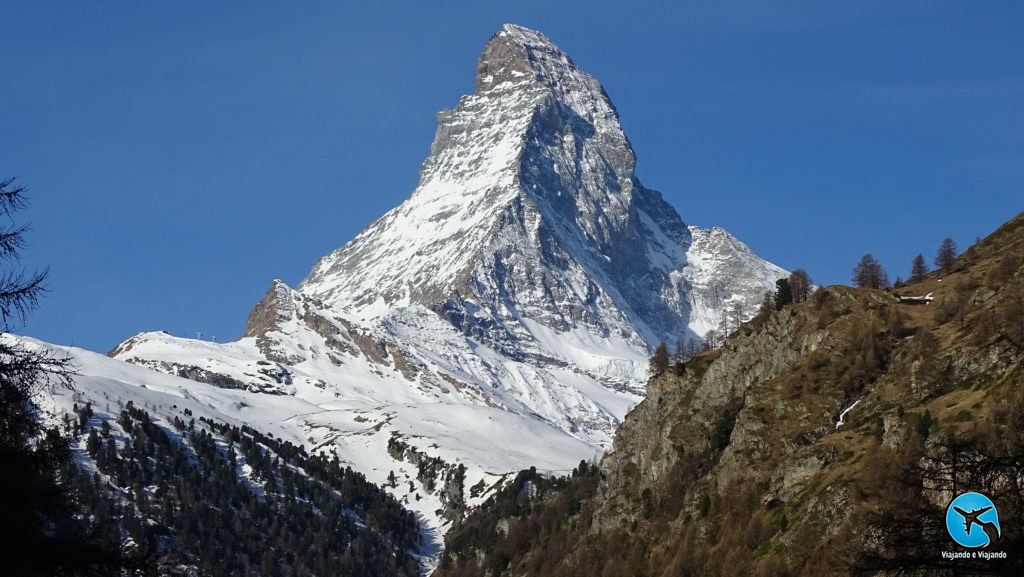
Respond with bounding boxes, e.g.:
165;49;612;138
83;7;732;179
435;214;1024;577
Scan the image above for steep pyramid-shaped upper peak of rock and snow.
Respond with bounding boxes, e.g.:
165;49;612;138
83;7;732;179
298;25;784;356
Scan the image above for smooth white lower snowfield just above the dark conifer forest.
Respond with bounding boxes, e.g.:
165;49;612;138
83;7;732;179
32;333;594;572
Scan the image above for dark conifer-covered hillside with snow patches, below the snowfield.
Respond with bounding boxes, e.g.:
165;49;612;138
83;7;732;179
65;401;419;577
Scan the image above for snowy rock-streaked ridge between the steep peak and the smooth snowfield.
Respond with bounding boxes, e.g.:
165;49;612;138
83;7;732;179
111;281;642;446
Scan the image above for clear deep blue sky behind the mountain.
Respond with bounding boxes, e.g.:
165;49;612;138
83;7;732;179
0;0;1024;352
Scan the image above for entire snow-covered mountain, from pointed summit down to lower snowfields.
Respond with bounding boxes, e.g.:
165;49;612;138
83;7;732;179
49;25;785;553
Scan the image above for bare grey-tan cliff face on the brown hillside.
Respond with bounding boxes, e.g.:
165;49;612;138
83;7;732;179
597;289;847;528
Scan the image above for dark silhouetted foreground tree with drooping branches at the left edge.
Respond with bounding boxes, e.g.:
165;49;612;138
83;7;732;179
0;178;126;575
